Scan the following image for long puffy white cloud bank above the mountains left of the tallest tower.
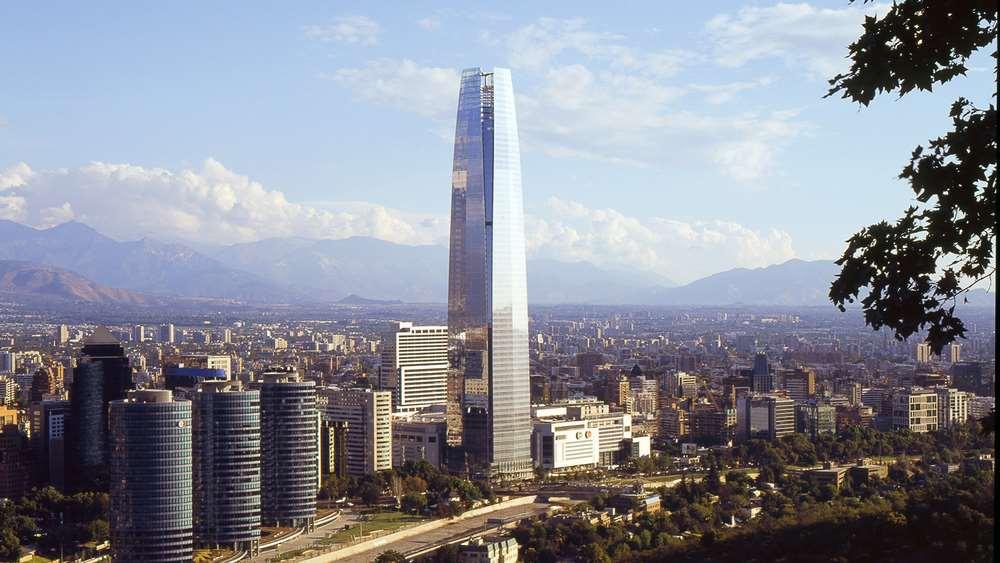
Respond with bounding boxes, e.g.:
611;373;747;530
0;159;444;244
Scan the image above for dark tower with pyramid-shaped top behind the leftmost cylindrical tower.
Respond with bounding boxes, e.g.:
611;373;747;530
66;326;132;491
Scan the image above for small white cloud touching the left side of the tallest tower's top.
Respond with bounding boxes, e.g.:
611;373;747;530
332;59;460;118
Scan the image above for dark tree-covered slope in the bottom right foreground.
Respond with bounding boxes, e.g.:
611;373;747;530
514;456;993;563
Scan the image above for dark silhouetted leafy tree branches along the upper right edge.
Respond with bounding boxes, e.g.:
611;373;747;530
827;0;997;353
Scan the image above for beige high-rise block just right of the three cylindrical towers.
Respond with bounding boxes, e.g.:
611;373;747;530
320;387;392;477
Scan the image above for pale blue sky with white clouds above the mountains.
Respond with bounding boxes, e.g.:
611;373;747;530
0;1;993;281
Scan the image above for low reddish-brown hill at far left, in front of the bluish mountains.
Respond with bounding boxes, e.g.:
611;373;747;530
0;260;150;305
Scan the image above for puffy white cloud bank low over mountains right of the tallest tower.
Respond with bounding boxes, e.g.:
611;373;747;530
526;198;795;282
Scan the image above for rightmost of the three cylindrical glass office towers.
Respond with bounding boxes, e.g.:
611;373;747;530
258;372;319;527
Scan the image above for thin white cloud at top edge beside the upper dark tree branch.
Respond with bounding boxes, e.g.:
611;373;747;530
705;2;885;78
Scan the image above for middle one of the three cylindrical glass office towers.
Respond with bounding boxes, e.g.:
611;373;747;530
191;382;261;553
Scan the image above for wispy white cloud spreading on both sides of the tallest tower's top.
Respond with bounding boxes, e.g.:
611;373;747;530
325;18;802;183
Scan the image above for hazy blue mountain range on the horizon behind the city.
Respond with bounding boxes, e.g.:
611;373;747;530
0;220;993;306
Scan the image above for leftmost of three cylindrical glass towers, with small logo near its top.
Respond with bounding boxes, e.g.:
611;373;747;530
108;389;193;563
